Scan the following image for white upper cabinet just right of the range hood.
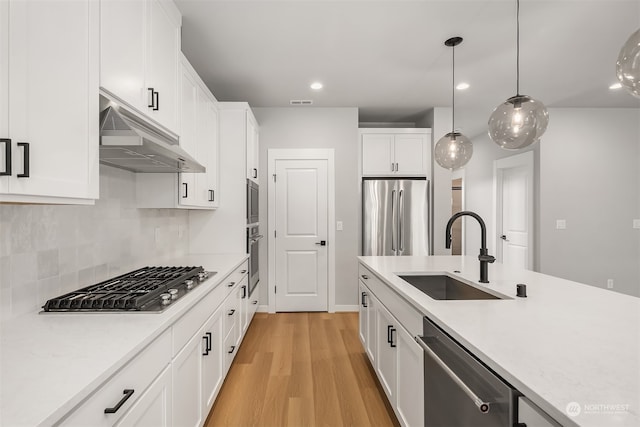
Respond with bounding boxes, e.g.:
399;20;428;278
136;56;220;209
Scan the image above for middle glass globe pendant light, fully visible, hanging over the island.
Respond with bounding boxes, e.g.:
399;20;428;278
489;0;549;150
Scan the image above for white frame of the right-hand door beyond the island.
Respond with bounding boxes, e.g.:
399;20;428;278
492;151;535;270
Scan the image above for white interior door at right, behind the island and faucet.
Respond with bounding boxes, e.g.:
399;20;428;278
496;153;533;269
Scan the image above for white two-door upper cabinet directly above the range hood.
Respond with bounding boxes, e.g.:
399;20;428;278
100;0;181;134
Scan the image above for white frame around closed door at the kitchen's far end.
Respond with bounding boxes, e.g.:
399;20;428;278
267;148;336;313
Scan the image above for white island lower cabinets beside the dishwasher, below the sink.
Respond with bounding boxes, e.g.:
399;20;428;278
358;264;424;426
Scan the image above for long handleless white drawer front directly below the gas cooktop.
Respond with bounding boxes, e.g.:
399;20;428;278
172;284;227;356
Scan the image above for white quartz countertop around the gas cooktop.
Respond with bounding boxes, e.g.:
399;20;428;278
0;254;247;427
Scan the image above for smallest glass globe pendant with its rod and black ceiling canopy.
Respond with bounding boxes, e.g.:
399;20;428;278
434;37;473;170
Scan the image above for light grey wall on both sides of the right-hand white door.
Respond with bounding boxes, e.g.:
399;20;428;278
458;108;640;295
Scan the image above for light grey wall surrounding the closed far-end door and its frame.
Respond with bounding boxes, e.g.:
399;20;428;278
253;107;359;308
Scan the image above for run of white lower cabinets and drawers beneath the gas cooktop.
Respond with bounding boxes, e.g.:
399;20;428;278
56;262;252;427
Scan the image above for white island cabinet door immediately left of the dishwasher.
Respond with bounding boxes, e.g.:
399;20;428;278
396;327;424;427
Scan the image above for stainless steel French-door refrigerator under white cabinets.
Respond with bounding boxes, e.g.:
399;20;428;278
362;178;432;256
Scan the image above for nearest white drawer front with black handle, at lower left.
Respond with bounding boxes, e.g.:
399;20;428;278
59;329;171;427
